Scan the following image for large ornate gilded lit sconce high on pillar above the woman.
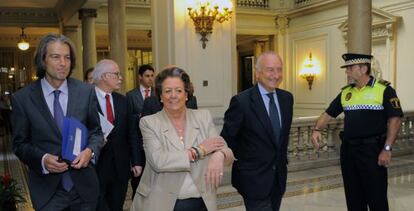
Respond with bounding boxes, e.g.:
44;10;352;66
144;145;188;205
187;0;233;49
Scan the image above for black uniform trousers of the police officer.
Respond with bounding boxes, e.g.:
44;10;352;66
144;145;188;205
341;141;389;211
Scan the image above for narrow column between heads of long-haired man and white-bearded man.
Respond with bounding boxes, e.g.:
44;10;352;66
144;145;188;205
79;9;97;75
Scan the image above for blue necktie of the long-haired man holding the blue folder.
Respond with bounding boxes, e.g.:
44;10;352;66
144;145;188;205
53;90;73;191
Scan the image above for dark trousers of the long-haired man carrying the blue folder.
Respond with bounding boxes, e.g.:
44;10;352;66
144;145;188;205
38;185;97;211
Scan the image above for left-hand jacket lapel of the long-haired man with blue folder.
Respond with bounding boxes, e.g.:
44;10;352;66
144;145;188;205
30;79;61;135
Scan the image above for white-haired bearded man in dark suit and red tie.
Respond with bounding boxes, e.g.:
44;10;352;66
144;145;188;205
93;59;139;211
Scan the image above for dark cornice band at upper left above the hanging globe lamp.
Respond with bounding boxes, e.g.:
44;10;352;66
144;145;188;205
0;7;59;27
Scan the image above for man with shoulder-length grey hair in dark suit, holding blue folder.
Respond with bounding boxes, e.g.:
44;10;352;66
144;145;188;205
12;34;103;211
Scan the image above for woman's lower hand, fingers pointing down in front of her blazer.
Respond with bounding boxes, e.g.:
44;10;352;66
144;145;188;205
205;152;224;190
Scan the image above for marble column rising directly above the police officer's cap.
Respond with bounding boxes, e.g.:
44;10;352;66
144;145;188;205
348;0;372;54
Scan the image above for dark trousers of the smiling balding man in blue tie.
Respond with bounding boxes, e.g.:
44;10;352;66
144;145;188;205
243;180;283;211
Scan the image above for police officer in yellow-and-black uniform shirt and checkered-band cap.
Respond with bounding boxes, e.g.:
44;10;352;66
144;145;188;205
312;53;403;211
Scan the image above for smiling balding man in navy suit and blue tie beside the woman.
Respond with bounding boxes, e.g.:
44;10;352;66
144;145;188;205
221;52;293;211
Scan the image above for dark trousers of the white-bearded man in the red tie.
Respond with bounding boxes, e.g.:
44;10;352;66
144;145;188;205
97;154;128;211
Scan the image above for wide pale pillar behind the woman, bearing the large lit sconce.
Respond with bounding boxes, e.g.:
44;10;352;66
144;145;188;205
151;0;237;117
